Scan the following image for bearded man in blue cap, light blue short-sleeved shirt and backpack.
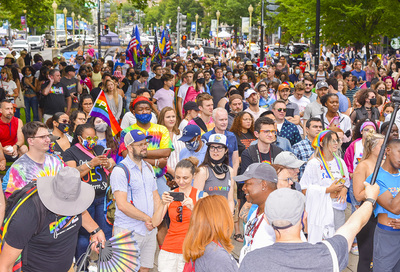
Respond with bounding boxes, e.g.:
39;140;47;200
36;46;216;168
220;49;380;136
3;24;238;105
110;129;160;271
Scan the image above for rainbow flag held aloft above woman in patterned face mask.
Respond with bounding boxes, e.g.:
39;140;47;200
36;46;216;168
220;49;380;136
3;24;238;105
89;91;122;136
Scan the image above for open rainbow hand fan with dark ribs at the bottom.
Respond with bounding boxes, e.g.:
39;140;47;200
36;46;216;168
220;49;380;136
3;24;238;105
97;231;140;272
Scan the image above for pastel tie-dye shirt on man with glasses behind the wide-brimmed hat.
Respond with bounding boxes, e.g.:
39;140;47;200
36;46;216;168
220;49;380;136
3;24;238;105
3;154;64;197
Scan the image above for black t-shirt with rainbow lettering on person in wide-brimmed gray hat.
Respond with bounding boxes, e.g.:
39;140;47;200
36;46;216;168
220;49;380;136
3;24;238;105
5;194;82;272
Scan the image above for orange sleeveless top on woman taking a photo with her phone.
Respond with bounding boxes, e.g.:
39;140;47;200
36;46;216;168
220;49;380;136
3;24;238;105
161;187;198;254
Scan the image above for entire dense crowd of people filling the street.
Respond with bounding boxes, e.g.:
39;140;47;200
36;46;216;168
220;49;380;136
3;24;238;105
0;45;400;271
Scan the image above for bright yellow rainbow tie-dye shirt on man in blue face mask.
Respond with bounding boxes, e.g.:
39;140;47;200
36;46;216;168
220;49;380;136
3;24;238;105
118;123;174;178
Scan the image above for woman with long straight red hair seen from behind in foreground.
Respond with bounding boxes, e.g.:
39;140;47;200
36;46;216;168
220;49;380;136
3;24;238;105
183;195;238;272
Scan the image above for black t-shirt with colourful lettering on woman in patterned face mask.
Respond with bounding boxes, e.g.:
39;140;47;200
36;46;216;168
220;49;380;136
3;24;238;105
63;145;107;198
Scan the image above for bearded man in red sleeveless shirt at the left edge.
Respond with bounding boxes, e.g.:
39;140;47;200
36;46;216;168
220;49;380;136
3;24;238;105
0;100;28;170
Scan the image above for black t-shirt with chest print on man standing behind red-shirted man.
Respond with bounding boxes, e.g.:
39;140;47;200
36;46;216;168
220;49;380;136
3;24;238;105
42;81;70;115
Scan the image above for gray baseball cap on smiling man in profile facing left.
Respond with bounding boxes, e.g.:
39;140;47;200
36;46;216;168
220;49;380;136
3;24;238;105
233;163;278;183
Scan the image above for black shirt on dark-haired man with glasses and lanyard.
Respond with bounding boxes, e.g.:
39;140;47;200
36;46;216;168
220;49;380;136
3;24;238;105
240;144;283;174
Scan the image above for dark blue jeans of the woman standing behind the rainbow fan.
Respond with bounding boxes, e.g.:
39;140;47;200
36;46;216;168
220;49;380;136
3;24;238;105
75;197;112;260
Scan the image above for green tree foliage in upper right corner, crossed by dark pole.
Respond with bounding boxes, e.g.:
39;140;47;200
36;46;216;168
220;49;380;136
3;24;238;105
277;0;400;57
